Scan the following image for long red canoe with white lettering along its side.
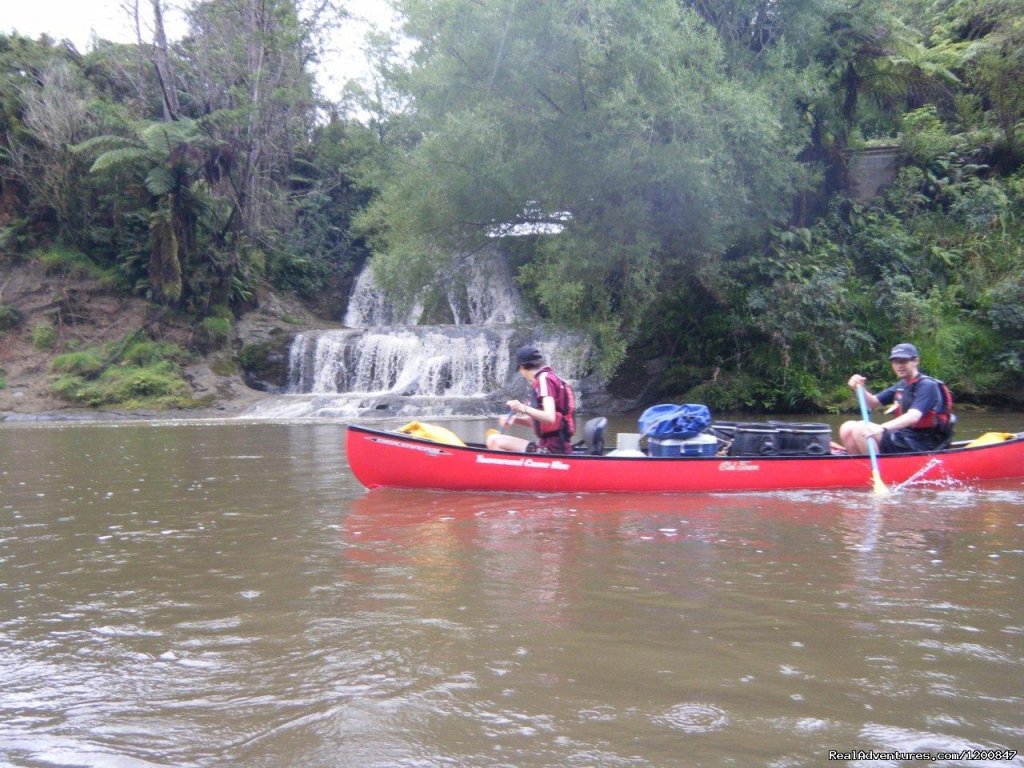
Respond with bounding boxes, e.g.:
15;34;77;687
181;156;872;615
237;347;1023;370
346;426;1024;494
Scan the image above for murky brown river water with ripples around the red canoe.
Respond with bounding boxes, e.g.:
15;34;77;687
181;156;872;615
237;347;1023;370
0;415;1024;768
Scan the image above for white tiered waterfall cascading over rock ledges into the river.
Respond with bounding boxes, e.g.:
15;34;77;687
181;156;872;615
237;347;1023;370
247;247;590;418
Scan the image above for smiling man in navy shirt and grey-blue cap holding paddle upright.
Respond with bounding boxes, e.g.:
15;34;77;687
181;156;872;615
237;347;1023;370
839;343;952;454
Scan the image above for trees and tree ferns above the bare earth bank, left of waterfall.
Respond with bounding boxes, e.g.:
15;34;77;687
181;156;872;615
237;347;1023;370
0;0;344;312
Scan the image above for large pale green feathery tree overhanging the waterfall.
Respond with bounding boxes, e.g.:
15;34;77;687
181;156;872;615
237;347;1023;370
360;0;809;367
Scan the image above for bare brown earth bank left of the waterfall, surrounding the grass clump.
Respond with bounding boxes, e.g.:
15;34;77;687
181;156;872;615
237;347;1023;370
0;261;332;422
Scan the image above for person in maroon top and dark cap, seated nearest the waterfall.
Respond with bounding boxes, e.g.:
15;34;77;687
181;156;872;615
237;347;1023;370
487;346;575;454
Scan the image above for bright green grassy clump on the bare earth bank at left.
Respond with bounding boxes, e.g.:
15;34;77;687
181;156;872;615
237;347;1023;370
50;335;203;411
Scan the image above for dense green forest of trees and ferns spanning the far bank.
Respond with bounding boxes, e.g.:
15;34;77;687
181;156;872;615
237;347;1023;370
0;0;1024;412
